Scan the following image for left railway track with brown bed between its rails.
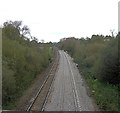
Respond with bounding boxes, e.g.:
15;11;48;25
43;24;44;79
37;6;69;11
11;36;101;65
26;50;59;111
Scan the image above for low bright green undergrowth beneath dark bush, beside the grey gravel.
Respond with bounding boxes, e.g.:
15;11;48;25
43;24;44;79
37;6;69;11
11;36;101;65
86;76;120;111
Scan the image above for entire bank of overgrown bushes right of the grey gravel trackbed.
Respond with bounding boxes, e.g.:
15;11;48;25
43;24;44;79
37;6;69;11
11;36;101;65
58;35;120;111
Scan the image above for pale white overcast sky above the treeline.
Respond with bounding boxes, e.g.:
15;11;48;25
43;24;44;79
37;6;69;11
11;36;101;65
0;0;119;42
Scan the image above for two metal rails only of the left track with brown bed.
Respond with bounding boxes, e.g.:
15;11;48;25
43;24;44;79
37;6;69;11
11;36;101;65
26;51;59;111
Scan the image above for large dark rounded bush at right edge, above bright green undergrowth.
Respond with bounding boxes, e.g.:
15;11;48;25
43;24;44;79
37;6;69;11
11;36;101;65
95;39;119;84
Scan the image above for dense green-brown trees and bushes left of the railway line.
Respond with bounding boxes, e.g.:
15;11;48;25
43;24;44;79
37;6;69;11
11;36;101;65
2;21;54;109
